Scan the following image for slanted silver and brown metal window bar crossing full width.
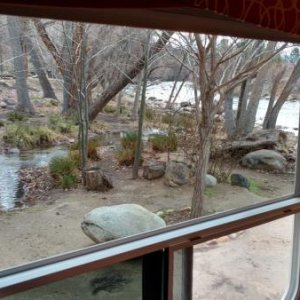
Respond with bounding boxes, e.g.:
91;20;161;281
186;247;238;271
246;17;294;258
0;197;300;297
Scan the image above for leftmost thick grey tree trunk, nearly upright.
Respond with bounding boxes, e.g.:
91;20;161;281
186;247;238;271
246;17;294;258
7;16;34;115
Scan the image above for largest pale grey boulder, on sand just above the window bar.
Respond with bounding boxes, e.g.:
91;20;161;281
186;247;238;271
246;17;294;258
81;204;166;243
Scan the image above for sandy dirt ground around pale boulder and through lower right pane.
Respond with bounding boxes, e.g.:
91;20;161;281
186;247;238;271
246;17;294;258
0;148;293;300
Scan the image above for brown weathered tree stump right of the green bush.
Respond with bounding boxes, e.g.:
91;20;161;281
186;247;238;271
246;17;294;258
84;167;113;192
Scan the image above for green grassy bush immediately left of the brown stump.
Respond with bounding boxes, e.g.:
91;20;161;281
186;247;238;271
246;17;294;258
49;156;76;189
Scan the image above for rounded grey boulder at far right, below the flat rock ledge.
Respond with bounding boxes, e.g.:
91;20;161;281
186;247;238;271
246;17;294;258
240;150;286;170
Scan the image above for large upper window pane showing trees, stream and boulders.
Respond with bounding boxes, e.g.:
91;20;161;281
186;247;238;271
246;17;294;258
0;16;300;269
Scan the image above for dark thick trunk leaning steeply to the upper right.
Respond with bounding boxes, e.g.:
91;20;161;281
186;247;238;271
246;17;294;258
89;31;172;120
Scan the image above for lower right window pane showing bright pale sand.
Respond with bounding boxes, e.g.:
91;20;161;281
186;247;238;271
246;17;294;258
193;217;292;300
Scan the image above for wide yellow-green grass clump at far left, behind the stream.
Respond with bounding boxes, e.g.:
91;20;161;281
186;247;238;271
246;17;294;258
3;122;57;149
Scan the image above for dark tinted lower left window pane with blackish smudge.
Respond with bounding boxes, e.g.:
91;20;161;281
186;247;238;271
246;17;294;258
4;259;142;300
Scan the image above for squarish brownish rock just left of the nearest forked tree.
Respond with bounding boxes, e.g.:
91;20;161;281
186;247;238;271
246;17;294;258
164;161;190;187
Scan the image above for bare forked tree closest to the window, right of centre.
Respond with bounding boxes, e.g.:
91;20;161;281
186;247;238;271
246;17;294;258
191;34;281;218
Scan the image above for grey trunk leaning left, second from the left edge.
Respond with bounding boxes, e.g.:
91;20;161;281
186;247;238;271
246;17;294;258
23;36;57;99
